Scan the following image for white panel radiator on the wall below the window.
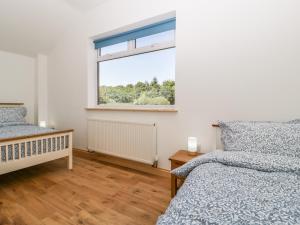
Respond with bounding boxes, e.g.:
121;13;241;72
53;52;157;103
88;119;157;165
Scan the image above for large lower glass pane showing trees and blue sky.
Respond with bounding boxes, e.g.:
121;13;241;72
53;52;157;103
98;48;176;105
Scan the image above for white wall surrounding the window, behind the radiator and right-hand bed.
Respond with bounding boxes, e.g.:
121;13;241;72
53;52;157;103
48;0;300;168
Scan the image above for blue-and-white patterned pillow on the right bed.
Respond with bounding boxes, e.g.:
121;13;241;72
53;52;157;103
219;121;300;158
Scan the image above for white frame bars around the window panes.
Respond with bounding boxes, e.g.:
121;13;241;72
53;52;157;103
96;29;176;108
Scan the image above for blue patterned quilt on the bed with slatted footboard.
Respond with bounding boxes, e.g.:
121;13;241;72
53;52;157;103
0;124;53;139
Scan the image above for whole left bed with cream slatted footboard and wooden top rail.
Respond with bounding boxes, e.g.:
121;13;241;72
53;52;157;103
0;103;73;174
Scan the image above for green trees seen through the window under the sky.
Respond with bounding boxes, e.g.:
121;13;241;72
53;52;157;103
99;77;175;105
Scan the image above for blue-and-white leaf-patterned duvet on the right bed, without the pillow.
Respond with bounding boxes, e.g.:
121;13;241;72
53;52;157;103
157;151;300;225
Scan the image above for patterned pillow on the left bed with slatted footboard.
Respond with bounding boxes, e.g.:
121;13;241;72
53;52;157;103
0;107;27;125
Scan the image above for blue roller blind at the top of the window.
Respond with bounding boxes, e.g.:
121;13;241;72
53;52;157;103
94;18;176;49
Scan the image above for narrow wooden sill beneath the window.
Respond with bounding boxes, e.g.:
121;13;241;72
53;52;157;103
85;106;178;113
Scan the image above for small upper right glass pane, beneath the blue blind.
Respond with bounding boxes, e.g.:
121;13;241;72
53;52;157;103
136;30;175;48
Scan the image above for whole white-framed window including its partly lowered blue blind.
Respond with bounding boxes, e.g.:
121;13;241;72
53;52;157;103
95;19;176;105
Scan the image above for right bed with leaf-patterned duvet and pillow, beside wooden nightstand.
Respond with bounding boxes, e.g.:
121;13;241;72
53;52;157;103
157;121;300;225
